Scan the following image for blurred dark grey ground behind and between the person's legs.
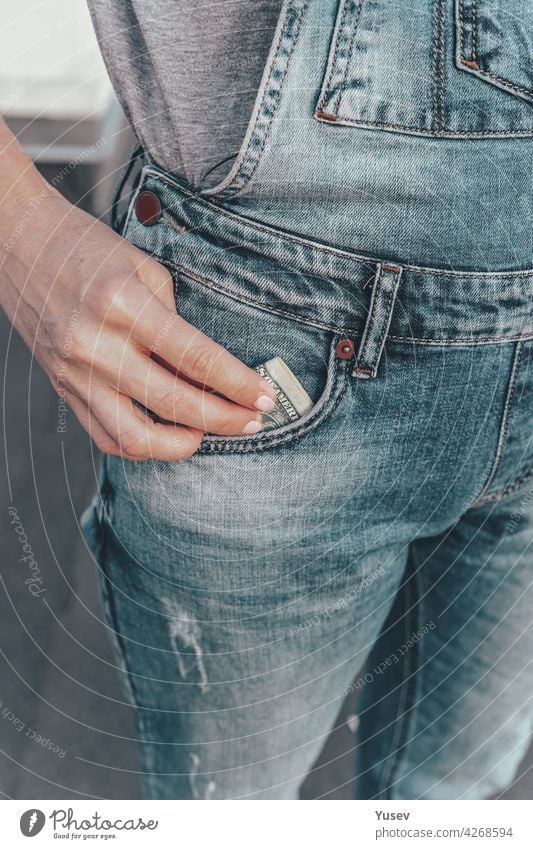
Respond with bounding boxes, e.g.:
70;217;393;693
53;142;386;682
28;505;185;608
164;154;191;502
0;161;533;799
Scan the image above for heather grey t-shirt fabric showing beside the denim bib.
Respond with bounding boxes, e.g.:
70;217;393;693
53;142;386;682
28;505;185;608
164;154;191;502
87;0;282;187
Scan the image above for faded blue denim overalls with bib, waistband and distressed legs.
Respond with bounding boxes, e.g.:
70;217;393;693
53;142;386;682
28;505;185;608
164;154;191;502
80;0;533;799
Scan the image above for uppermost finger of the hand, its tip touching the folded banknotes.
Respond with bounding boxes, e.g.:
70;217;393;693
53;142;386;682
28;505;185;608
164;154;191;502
106;274;275;412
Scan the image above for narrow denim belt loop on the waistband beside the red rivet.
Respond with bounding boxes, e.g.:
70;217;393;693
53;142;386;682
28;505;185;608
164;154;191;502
352;262;402;379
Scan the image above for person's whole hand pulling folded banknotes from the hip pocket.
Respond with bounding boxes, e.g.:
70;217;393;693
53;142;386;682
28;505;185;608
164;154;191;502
0;122;273;460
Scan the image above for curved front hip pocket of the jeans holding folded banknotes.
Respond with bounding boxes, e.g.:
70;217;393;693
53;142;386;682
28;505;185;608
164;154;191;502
168;269;347;453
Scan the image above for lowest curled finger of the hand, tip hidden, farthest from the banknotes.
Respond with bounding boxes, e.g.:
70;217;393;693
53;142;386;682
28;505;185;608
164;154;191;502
89;385;204;460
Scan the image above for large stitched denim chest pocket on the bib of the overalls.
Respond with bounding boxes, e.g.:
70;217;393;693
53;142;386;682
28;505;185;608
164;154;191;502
315;0;533;138
